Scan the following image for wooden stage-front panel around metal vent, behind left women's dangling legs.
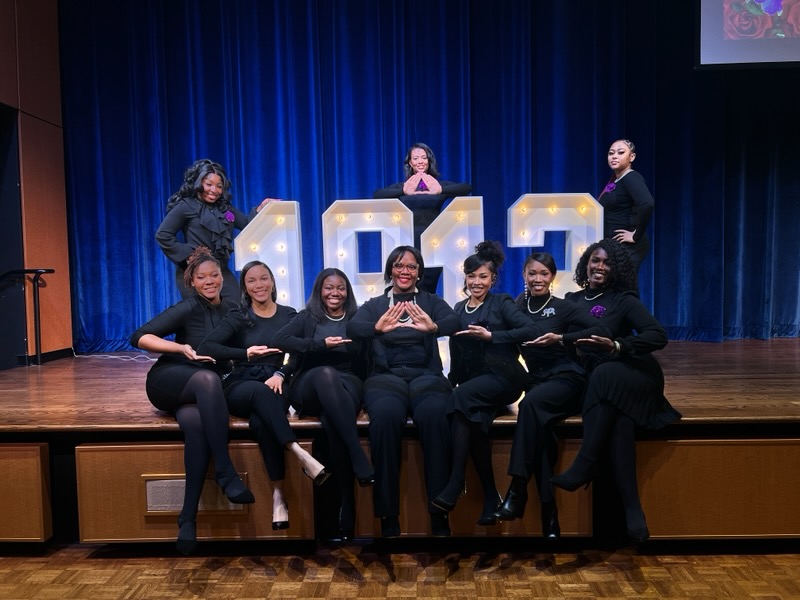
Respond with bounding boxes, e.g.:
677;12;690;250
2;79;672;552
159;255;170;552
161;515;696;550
75;441;315;542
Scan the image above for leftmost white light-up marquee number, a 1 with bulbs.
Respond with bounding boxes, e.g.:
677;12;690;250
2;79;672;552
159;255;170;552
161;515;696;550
233;200;305;306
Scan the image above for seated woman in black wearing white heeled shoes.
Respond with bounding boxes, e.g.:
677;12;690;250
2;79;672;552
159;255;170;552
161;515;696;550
200;260;329;530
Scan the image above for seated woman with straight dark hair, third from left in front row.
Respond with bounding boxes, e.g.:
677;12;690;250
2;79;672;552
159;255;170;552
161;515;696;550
275;268;375;540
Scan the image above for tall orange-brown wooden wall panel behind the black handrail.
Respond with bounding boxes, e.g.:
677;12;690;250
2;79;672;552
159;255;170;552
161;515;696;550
19;113;72;355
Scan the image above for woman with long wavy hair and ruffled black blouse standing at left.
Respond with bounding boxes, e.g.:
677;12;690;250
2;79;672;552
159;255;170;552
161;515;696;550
156;158;272;301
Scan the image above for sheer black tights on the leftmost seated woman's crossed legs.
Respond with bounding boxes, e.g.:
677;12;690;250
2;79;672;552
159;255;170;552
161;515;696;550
175;369;236;517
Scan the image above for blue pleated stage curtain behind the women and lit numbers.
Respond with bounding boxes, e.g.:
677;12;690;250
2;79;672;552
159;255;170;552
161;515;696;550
59;0;800;352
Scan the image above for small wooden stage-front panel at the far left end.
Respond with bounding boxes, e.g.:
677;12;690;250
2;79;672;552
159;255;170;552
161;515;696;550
0;444;53;542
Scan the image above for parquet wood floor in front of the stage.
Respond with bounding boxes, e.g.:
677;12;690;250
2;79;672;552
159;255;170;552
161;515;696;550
0;545;800;600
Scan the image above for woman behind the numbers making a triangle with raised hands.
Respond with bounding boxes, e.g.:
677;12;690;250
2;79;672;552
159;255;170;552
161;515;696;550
373;142;472;294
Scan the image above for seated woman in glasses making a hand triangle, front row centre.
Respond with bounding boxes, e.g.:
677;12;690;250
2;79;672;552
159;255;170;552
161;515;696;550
347;246;459;537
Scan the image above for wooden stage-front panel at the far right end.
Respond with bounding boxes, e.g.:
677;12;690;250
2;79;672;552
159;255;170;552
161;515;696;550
637;439;800;539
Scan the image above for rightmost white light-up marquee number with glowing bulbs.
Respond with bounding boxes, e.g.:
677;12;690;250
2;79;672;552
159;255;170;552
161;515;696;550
507;194;603;296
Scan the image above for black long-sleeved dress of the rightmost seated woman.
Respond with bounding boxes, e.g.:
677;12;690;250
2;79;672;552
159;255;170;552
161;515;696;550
564;288;681;429
